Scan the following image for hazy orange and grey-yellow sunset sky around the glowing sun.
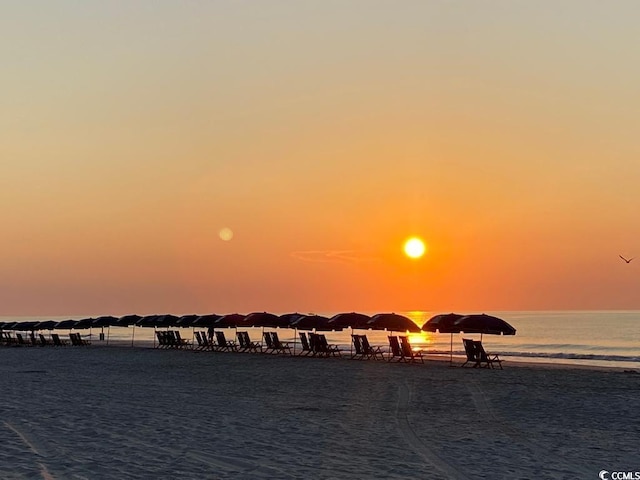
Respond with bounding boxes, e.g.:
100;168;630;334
0;0;640;316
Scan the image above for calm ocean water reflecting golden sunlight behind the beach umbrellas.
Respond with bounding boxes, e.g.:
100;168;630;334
0;310;640;369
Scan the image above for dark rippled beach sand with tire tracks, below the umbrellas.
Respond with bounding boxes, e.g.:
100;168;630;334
0;346;640;480
